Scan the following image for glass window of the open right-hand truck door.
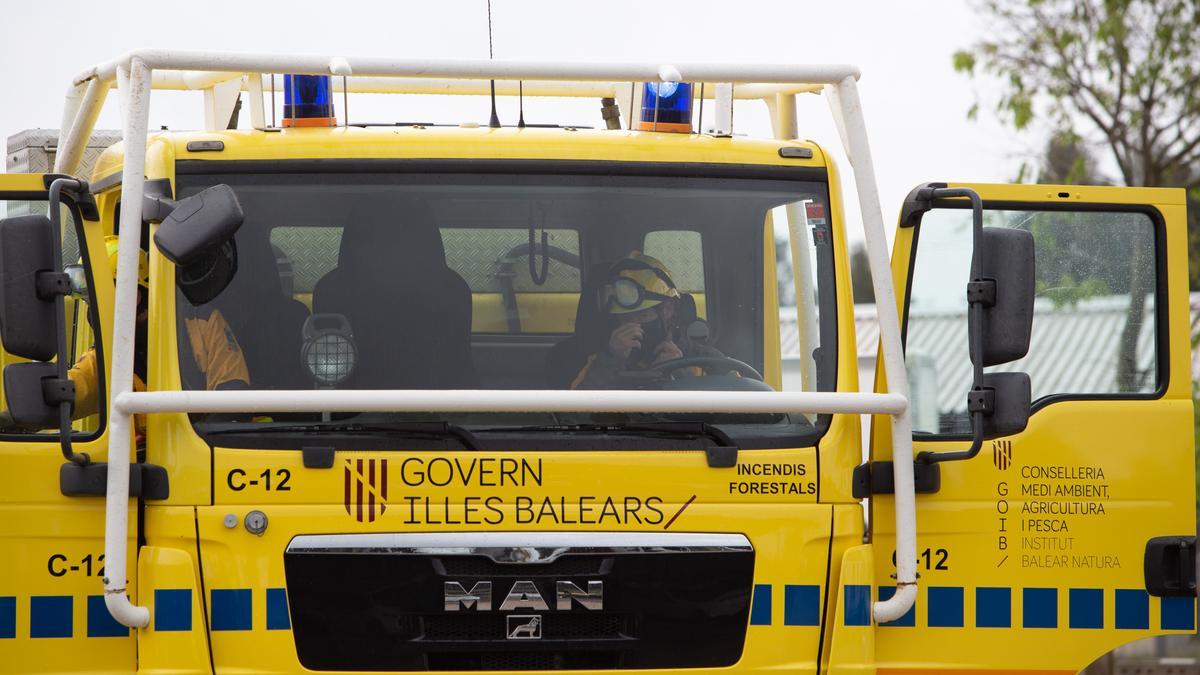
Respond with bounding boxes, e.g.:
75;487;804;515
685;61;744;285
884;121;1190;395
905;209;1162;434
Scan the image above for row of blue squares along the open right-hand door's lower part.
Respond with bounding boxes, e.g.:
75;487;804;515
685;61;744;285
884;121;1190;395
842;585;1196;631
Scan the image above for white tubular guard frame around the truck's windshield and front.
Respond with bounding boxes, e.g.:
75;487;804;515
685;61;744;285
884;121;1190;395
68;49;917;627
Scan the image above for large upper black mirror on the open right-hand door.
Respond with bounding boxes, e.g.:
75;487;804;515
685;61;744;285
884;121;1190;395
968;227;1036;366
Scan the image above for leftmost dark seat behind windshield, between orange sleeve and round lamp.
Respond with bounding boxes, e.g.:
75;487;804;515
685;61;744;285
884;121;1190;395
201;228;312;389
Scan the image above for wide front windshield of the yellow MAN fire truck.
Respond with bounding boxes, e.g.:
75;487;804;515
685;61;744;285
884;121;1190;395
176;165;836;447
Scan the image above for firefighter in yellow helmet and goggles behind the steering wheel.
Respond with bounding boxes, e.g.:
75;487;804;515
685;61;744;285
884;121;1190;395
571;251;722;389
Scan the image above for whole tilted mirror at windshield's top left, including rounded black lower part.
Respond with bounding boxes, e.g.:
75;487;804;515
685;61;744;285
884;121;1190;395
154;185;245;305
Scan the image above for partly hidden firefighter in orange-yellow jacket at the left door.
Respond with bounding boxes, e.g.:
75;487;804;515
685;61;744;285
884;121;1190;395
0;237;250;427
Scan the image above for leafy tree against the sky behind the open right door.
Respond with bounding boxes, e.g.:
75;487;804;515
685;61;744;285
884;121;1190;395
953;0;1200;289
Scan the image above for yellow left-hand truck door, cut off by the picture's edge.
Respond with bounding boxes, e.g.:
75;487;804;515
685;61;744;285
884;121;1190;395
0;174;137;673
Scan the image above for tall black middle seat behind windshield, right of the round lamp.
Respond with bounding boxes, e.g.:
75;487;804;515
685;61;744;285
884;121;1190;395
313;204;478;389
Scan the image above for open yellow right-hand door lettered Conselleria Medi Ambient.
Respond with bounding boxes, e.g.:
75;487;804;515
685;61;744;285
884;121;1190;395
871;185;1196;673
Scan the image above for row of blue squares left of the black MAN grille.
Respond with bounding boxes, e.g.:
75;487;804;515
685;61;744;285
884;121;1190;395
0;589;292;640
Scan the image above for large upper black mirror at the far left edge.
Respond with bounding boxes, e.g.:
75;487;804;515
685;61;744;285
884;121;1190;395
0;215;58;362
